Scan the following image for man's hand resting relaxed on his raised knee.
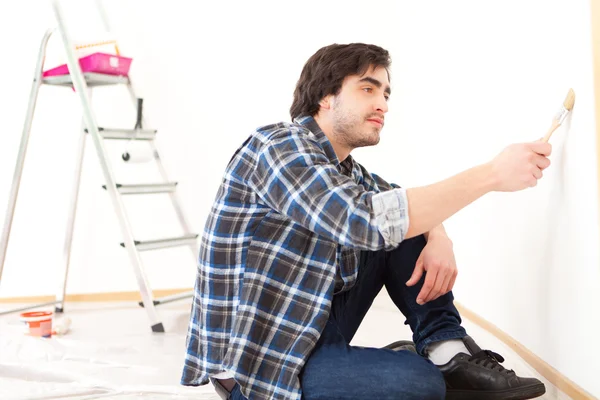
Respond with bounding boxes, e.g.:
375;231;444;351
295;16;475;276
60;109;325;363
406;235;458;305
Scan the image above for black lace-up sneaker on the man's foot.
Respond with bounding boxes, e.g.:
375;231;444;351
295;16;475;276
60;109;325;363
438;336;546;400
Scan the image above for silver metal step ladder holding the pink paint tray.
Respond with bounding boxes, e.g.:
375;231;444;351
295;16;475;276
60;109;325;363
0;0;198;332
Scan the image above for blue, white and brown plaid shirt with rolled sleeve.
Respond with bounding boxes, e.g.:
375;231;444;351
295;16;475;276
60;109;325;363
181;117;409;399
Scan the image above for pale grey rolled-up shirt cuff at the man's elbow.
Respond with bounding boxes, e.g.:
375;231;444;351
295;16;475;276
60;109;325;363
372;188;409;250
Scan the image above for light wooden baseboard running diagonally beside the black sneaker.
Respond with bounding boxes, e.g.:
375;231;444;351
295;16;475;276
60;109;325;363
454;302;596;400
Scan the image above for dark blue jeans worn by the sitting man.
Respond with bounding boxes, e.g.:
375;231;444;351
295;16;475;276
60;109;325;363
231;235;467;400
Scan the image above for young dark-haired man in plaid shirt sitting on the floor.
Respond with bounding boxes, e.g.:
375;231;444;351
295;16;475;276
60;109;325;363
182;43;551;400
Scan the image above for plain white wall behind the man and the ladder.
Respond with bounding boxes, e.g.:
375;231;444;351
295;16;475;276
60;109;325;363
0;0;600;396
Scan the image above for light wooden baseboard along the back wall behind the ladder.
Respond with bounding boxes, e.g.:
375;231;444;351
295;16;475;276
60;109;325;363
0;288;193;303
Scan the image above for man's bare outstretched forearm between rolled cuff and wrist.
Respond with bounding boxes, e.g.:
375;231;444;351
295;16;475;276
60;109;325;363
405;164;495;239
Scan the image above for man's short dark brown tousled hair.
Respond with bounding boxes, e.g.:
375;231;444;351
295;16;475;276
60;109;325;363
290;43;392;119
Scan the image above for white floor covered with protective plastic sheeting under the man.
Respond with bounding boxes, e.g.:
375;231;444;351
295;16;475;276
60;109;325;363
0;291;570;400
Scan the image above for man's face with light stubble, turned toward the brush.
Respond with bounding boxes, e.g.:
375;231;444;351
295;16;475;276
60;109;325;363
331;67;391;149
